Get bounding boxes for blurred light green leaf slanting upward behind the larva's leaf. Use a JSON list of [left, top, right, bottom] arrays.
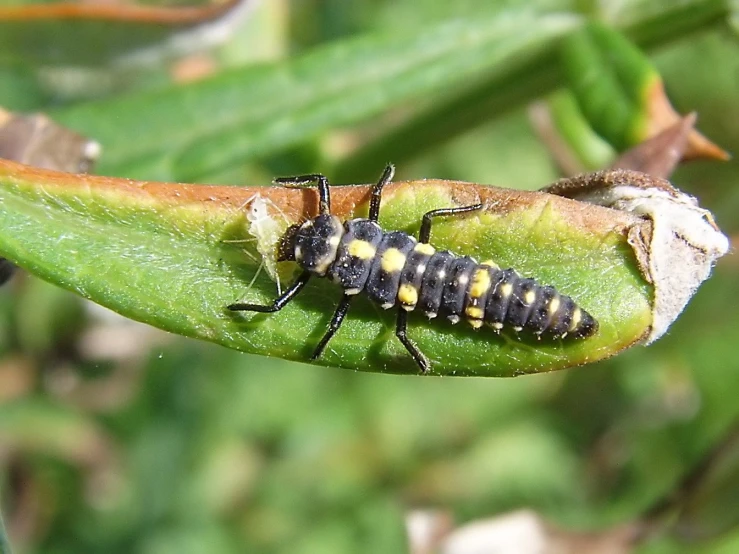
[[53, 10, 579, 181]]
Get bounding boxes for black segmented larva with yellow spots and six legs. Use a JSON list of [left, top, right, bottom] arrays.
[[228, 165, 598, 373]]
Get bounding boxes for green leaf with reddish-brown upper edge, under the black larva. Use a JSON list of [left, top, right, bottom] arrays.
[[0, 162, 651, 376]]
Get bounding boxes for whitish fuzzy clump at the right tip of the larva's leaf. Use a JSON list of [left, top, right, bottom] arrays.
[[577, 184, 729, 344]]
